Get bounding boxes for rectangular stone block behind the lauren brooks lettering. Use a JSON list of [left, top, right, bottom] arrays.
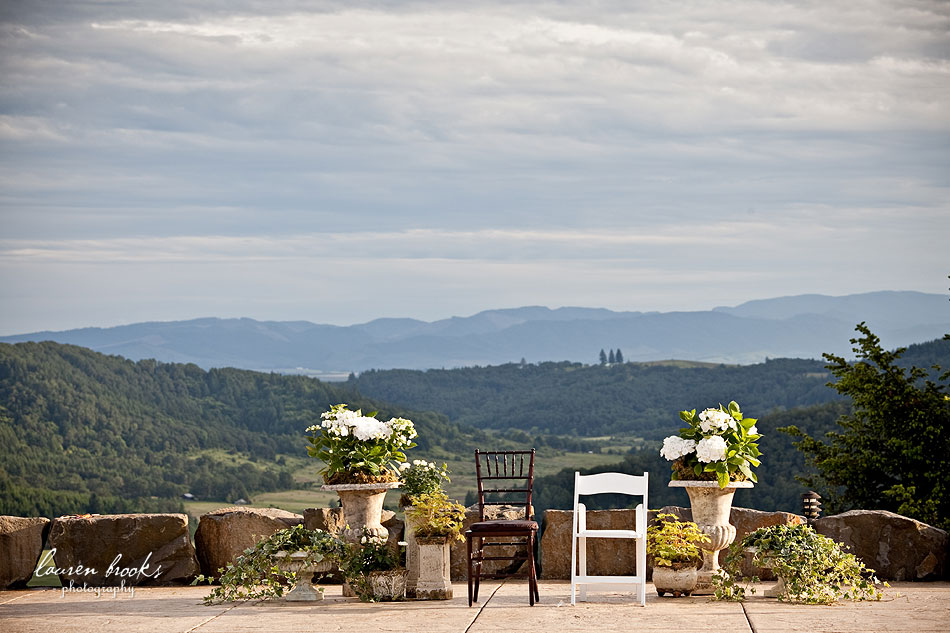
[[49, 514, 198, 587]]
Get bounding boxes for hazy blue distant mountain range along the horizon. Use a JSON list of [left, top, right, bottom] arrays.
[[0, 291, 950, 378]]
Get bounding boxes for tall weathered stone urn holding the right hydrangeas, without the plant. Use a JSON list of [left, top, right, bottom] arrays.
[[670, 480, 753, 596]]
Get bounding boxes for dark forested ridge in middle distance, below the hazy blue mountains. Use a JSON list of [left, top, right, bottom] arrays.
[[345, 352, 852, 439]]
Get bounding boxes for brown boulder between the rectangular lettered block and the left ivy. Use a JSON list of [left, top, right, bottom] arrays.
[[195, 506, 303, 578]]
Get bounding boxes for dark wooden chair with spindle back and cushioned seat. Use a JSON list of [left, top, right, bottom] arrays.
[[465, 449, 540, 606]]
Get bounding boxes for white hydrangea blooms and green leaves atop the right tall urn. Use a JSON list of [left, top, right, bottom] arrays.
[[660, 400, 761, 488]]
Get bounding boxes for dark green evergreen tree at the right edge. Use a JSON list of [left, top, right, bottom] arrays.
[[782, 323, 950, 529]]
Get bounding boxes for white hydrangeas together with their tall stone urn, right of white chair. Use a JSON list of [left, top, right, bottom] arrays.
[[660, 401, 761, 595]]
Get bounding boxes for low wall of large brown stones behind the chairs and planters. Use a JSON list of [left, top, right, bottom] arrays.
[[0, 506, 950, 589]]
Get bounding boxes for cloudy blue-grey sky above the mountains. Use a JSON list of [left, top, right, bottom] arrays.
[[0, 0, 950, 334]]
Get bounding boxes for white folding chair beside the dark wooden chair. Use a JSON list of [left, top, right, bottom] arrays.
[[571, 472, 649, 606]]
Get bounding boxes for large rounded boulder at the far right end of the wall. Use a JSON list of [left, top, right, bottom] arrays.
[[814, 510, 948, 580]]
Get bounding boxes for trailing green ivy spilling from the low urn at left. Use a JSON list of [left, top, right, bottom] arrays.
[[192, 525, 346, 604]]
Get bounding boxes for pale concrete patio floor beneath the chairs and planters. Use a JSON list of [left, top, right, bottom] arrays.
[[0, 580, 950, 633]]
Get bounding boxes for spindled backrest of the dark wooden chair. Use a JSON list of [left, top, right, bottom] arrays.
[[475, 448, 534, 521]]
